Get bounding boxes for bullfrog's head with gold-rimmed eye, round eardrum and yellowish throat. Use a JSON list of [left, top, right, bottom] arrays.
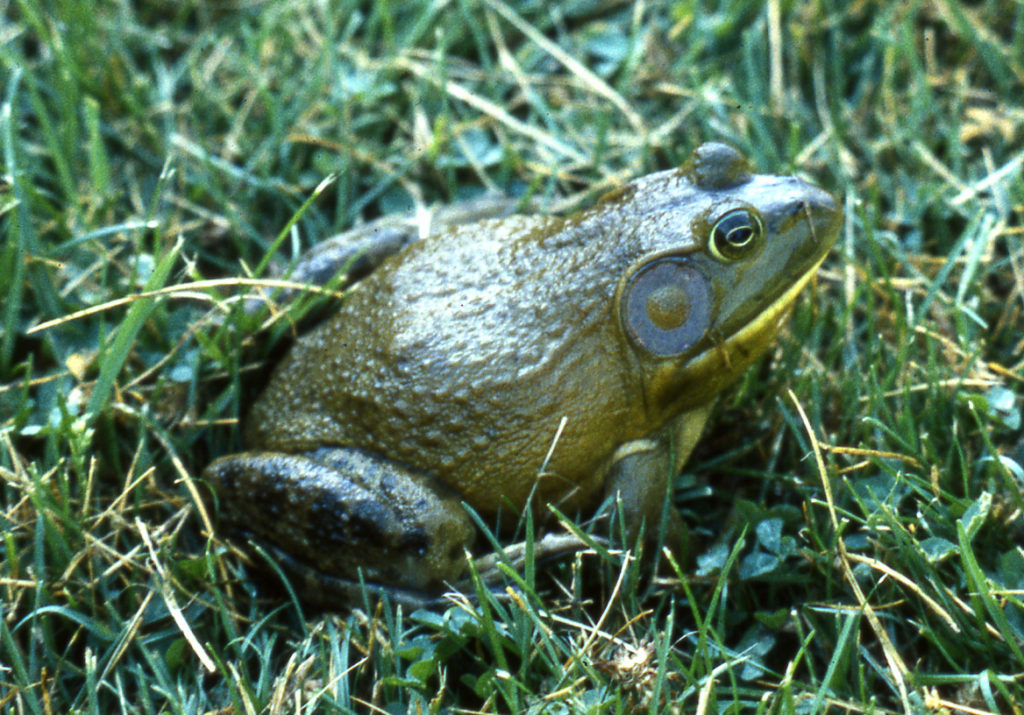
[[615, 143, 842, 411]]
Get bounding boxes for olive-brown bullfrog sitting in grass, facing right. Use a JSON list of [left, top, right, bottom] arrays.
[[204, 143, 841, 593]]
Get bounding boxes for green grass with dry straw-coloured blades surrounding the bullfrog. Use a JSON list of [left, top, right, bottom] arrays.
[[0, 0, 1024, 713]]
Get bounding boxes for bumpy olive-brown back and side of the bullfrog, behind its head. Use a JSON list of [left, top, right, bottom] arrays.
[[248, 208, 636, 510]]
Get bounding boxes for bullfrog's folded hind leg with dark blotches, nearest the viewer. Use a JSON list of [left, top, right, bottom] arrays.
[[204, 448, 474, 600]]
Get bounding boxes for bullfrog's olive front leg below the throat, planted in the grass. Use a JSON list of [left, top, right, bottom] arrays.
[[604, 405, 711, 550]]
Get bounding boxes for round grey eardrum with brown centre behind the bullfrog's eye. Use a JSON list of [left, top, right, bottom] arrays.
[[623, 256, 712, 358]]
